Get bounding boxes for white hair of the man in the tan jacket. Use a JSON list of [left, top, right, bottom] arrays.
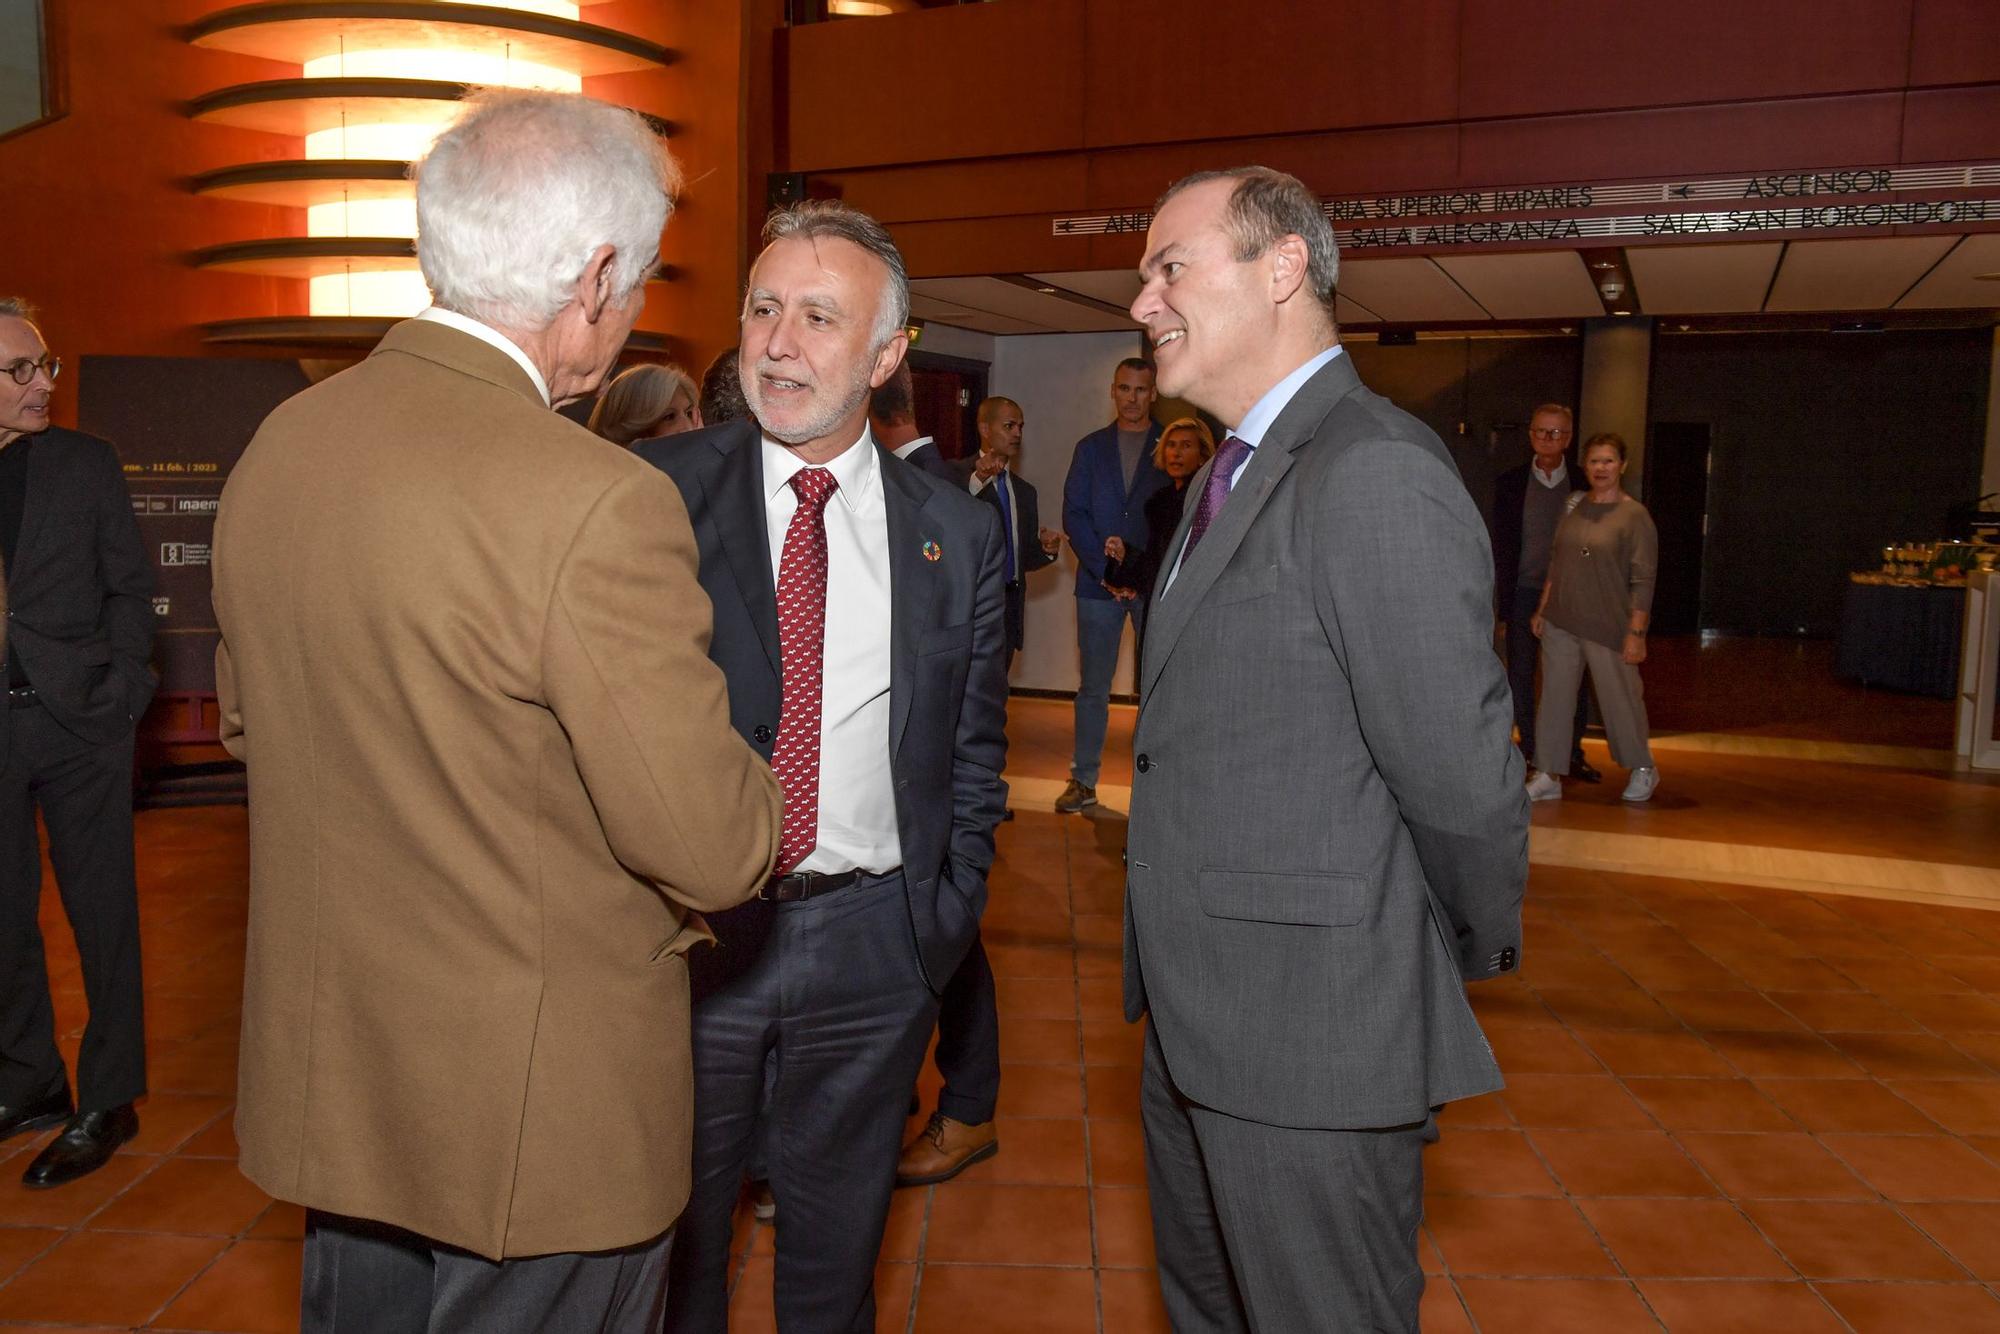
[[414, 90, 680, 330]]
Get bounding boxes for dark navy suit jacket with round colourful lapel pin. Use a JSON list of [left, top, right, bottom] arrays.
[[634, 422, 1006, 992]]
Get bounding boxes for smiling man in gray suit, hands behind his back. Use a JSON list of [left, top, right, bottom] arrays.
[[1124, 168, 1528, 1332]]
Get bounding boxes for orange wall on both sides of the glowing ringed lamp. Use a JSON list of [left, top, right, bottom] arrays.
[[0, 0, 782, 422]]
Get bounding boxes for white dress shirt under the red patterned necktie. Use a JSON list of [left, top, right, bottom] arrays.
[[764, 428, 902, 874]]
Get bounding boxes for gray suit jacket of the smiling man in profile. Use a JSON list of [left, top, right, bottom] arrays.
[[1124, 354, 1528, 1128]]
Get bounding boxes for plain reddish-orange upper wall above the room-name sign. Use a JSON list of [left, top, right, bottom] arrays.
[[780, 0, 2000, 274]]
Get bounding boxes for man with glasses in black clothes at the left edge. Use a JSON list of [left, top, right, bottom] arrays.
[[0, 300, 156, 1186]]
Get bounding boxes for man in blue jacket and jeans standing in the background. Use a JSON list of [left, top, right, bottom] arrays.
[[1056, 356, 1172, 814]]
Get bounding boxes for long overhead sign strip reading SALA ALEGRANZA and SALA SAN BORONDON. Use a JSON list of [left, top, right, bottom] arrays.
[[1052, 162, 2000, 250]]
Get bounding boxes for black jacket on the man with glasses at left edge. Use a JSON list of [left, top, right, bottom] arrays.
[[0, 426, 158, 756]]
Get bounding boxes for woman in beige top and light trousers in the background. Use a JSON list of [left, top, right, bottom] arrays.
[[1528, 432, 1660, 802]]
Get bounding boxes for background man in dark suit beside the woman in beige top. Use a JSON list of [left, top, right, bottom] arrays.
[[1488, 402, 1604, 782]]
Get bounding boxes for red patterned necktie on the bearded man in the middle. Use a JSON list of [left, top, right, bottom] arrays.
[[770, 468, 838, 876]]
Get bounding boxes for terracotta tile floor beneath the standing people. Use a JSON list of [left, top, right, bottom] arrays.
[[11, 702, 2000, 1334]]
